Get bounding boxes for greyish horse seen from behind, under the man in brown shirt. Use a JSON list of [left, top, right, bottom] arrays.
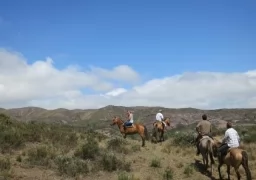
[[199, 136, 215, 175]]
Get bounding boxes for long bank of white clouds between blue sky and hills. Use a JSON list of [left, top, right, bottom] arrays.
[[0, 49, 256, 109]]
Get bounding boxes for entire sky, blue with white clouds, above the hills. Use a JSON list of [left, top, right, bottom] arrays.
[[0, 0, 256, 109]]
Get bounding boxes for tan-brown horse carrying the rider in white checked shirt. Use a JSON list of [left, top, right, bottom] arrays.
[[214, 140, 252, 180]]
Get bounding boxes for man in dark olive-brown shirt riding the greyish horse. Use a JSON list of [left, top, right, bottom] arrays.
[[196, 114, 213, 156]]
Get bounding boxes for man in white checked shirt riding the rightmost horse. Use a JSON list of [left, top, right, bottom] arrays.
[[218, 122, 240, 160]]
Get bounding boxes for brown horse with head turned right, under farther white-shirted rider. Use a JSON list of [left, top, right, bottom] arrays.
[[153, 117, 170, 142]]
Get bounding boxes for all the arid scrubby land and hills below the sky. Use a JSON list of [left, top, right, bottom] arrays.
[[0, 106, 256, 180]]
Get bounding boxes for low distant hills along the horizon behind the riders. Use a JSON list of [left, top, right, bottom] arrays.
[[0, 105, 256, 127]]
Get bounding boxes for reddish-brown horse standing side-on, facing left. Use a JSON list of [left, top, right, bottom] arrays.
[[111, 116, 148, 147]]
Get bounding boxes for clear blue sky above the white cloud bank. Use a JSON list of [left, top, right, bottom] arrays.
[[0, 0, 256, 78]]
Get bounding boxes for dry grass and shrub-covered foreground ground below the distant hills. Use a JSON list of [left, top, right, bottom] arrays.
[[0, 113, 256, 180]]
